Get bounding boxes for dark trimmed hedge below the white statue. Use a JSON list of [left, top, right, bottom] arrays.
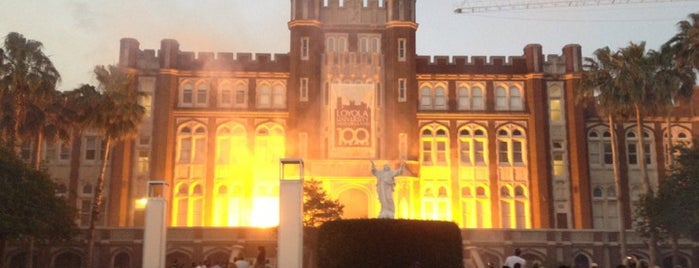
[[317, 219, 464, 268]]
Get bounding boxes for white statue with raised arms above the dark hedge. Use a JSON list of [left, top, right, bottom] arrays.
[[371, 161, 405, 219]]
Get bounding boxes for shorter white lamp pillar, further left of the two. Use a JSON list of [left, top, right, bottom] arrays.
[[143, 181, 168, 268]]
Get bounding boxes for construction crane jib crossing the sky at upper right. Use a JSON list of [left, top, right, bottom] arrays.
[[454, 0, 696, 14]]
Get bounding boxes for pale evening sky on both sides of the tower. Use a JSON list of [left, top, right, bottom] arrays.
[[0, 0, 699, 90]]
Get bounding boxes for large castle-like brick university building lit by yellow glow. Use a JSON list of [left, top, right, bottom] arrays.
[[6, 0, 699, 267]]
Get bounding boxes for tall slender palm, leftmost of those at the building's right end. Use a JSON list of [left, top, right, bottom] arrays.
[[577, 47, 633, 257]]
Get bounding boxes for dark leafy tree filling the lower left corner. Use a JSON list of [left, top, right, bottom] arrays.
[[0, 147, 77, 267]]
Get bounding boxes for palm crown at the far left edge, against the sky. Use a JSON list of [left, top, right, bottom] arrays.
[[0, 32, 61, 147]]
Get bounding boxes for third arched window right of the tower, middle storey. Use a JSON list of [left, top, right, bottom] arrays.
[[498, 127, 526, 166]]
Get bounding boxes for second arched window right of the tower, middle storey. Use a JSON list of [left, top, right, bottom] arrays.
[[459, 127, 487, 166]]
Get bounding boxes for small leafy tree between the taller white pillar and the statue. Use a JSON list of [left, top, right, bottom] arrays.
[[303, 180, 344, 227]]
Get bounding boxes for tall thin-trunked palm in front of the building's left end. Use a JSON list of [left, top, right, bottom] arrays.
[[84, 66, 145, 267]]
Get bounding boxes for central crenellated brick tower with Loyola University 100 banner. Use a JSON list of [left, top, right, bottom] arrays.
[[288, 0, 417, 163]]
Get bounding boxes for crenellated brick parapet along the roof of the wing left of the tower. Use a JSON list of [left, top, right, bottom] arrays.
[[119, 38, 289, 72]]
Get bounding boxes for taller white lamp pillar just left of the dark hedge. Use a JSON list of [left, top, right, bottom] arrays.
[[277, 158, 303, 268]]
